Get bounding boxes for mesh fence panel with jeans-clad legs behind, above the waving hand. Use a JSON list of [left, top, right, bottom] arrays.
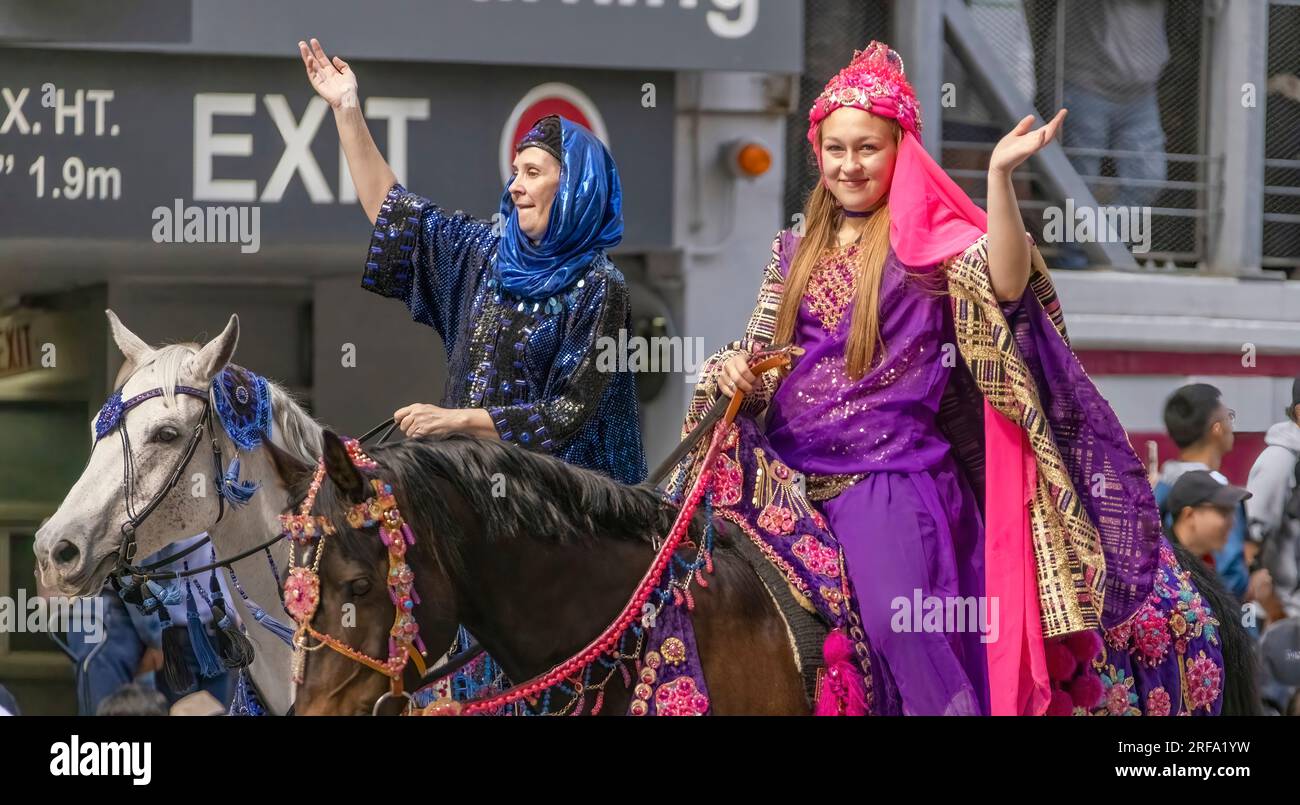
[[977, 0, 1217, 269]]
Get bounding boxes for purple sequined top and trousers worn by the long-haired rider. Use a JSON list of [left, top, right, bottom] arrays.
[[767, 246, 996, 715]]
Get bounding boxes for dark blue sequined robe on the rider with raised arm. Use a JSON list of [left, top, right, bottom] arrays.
[[361, 185, 646, 484]]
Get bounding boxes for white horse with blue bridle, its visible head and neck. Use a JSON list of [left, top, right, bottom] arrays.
[[35, 311, 321, 714]]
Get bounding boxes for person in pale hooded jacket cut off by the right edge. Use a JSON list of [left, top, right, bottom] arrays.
[[1245, 377, 1300, 618]]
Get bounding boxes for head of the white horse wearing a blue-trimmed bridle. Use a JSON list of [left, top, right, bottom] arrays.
[[35, 311, 239, 596]]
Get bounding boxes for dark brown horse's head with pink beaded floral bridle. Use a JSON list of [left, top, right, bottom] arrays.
[[285, 430, 458, 715]]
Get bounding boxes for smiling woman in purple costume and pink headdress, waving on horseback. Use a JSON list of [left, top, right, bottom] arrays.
[[686, 43, 1237, 715]]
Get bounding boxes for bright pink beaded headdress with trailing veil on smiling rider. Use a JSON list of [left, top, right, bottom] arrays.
[[809, 40, 988, 268]]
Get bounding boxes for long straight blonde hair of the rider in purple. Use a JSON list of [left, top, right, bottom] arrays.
[[775, 121, 902, 380]]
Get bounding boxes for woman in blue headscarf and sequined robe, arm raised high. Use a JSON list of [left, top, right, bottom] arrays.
[[305, 39, 646, 694]]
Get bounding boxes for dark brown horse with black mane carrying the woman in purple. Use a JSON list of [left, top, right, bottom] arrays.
[[277, 430, 810, 715]]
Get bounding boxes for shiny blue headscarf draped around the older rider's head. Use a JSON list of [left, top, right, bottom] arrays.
[[497, 117, 623, 299]]
